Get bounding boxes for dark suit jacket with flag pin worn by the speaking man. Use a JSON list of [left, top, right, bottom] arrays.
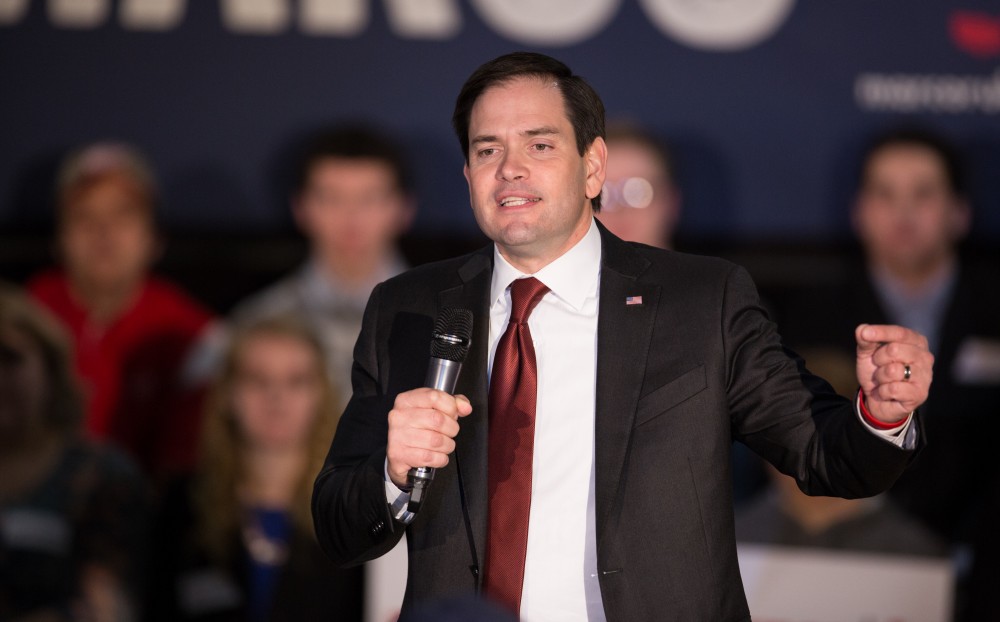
[[313, 227, 913, 622]]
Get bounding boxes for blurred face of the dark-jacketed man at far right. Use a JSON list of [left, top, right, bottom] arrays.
[[854, 144, 969, 275]]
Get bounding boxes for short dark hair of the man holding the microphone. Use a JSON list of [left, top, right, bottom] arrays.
[[451, 52, 604, 212]]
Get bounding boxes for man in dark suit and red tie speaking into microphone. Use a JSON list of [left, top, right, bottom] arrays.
[[313, 53, 932, 621]]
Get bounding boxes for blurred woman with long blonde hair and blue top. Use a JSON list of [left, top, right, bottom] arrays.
[[149, 317, 363, 621]]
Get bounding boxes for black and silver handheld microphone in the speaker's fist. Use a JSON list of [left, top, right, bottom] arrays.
[[407, 307, 472, 520]]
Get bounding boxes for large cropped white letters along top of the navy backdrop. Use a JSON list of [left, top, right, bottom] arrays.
[[0, 0, 795, 51]]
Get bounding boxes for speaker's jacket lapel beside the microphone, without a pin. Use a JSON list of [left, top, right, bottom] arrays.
[[439, 246, 493, 572]]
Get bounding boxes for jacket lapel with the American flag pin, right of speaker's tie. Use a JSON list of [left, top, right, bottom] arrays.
[[594, 223, 660, 549]]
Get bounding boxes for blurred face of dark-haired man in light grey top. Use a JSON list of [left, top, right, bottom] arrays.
[[294, 157, 413, 271]]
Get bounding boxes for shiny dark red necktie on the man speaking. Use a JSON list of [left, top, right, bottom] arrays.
[[484, 278, 549, 612]]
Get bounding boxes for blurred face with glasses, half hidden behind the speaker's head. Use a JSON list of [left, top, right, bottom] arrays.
[[597, 139, 680, 248]]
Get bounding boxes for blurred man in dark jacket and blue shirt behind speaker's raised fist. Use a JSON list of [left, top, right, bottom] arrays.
[[782, 127, 1000, 620]]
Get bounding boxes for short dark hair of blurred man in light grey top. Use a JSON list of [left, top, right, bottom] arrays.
[[294, 124, 412, 193]]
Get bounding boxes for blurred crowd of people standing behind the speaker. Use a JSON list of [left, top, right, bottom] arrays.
[[0, 122, 1000, 621]]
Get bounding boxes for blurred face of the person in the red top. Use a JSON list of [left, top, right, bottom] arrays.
[[59, 174, 157, 290]]
